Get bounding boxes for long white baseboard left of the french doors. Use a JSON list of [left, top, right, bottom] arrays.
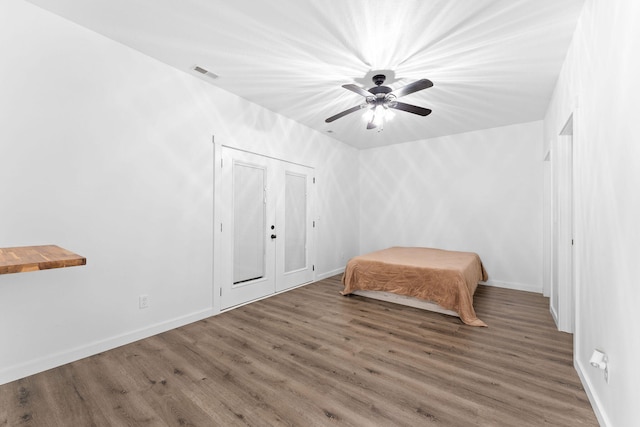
[[0, 309, 214, 385]]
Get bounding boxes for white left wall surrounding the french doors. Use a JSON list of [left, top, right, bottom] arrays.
[[0, 0, 358, 383]]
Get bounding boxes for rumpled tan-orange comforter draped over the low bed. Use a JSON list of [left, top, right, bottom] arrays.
[[342, 247, 488, 326]]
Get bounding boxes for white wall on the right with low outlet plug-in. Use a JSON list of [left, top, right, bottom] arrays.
[[544, 0, 640, 426]]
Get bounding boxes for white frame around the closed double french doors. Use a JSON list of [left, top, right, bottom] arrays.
[[212, 144, 317, 314]]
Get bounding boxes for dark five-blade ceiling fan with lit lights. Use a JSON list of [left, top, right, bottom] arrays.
[[325, 74, 433, 129]]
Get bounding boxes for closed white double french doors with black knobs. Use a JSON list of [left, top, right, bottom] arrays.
[[216, 147, 313, 309]]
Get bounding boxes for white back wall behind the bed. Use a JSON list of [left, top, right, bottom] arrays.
[[360, 122, 543, 292]]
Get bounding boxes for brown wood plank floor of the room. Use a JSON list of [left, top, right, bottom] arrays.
[[0, 277, 597, 427]]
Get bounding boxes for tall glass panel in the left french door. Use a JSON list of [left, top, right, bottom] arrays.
[[233, 163, 266, 285]]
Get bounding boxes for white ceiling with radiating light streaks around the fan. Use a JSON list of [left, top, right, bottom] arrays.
[[30, 0, 584, 148]]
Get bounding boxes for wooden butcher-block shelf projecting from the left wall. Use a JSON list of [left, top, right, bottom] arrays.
[[0, 245, 87, 274]]
